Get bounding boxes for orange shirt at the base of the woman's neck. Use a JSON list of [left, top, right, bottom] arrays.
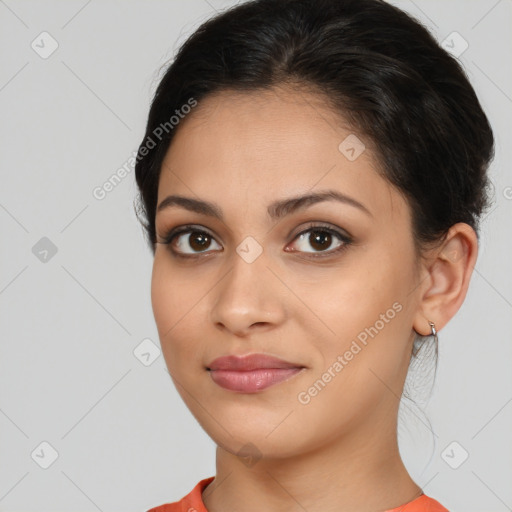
[[147, 476, 448, 512]]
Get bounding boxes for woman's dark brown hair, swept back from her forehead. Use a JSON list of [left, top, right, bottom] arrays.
[[135, 0, 494, 260]]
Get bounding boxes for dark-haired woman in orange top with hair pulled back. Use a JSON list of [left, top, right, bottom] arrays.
[[136, 0, 494, 512]]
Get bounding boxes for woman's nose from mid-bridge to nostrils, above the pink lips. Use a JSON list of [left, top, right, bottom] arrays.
[[211, 254, 286, 337]]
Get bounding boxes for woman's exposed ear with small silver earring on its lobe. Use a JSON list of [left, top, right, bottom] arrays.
[[413, 222, 478, 336]]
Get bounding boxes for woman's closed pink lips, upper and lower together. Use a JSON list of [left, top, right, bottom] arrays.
[[207, 354, 305, 393]]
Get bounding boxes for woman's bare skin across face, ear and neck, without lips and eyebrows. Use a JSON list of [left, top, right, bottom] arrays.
[[151, 86, 478, 512]]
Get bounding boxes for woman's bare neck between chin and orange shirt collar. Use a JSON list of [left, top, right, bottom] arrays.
[[203, 414, 422, 512]]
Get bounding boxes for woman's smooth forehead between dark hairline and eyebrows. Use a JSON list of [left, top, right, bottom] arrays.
[[158, 87, 405, 224]]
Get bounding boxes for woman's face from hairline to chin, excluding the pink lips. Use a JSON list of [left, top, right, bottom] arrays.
[[151, 88, 419, 458]]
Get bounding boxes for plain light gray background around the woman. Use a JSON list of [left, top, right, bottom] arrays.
[[0, 0, 512, 512]]
